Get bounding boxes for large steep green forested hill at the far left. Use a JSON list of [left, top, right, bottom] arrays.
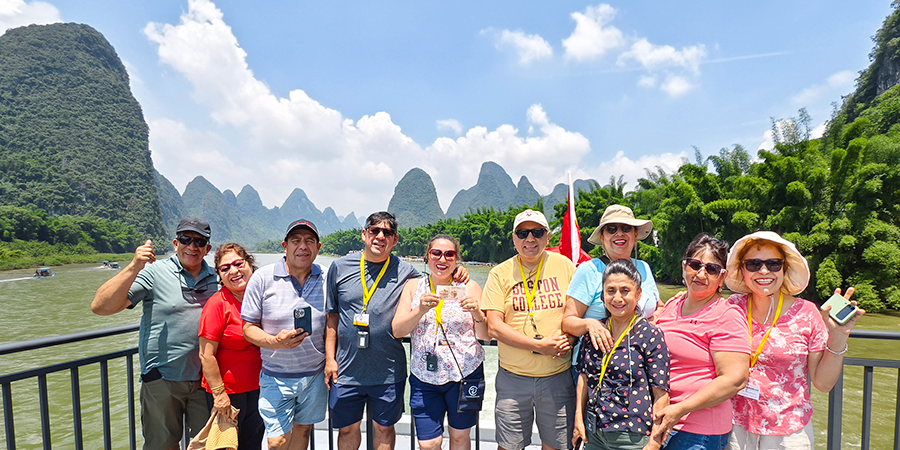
[[0, 24, 165, 237]]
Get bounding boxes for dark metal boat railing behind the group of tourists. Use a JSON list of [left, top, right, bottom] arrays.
[[0, 324, 900, 450]]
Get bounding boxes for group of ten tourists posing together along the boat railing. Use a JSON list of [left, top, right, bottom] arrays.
[[91, 205, 864, 450]]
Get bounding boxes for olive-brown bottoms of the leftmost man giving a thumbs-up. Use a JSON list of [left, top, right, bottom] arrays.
[[141, 378, 209, 450]]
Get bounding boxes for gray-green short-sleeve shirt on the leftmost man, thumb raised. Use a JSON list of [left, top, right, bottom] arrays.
[[128, 255, 219, 381]]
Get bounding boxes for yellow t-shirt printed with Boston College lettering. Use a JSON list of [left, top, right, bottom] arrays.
[[481, 252, 575, 377]]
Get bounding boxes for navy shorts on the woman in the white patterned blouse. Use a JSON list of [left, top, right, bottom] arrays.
[[409, 364, 484, 441]]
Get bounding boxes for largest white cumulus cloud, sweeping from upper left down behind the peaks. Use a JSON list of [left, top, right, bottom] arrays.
[[144, 0, 604, 216]]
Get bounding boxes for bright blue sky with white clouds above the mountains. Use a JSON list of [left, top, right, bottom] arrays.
[[0, 0, 891, 220]]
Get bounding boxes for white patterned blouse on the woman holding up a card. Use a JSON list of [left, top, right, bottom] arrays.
[[409, 278, 484, 385]]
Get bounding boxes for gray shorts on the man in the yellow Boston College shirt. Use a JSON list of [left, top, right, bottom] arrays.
[[494, 367, 575, 450]]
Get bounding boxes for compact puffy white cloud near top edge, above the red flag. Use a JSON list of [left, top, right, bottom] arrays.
[[563, 4, 625, 61]]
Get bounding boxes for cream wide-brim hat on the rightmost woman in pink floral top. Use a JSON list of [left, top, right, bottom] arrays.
[[725, 231, 809, 295]]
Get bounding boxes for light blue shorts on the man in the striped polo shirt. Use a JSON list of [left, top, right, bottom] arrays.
[[259, 372, 328, 438]]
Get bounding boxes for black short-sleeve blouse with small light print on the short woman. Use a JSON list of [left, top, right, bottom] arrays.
[[577, 318, 669, 436]]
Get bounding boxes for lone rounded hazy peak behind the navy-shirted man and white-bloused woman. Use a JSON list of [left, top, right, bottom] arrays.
[[388, 167, 444, 228]]
